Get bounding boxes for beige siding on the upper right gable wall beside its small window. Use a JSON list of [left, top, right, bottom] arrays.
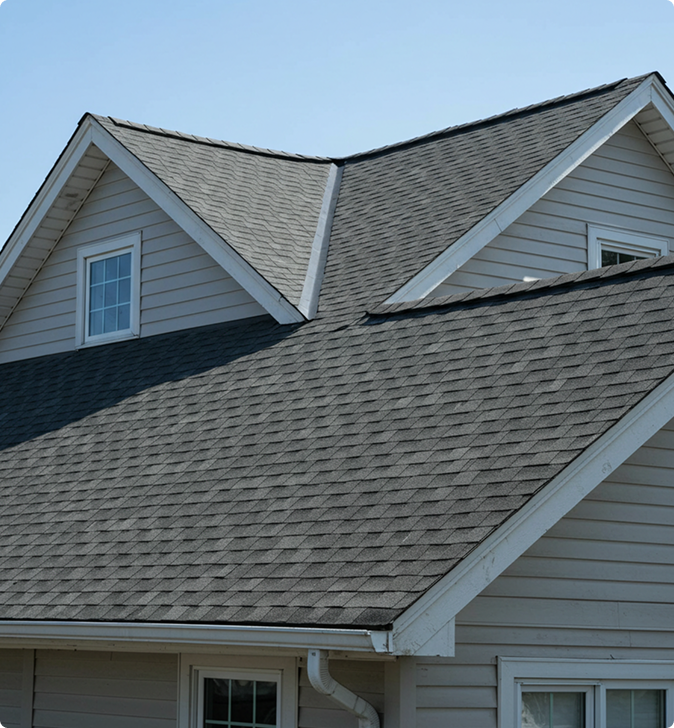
[[431, 122, 674, 296]]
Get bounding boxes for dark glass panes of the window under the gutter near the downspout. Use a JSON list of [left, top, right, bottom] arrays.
[[203, 677, 279, 728]]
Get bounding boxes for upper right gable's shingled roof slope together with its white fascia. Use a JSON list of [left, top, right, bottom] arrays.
[[321, 74, 672, 310]]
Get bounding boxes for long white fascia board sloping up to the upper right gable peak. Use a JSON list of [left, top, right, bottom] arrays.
[[385, 76, 657, 304]]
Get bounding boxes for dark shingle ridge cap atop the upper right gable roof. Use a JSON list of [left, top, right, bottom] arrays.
[[336, 71, 662, 161]]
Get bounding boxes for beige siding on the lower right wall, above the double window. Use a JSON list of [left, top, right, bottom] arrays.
[[417, 421, 674, 728]]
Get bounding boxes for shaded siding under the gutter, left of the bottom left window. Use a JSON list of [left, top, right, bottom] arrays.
[[33, 650, 178, 728]]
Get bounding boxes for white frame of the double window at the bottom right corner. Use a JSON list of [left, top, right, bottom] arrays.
[[498, 657, 674, 728]]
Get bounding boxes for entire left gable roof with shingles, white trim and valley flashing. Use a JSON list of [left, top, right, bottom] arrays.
[[0, 114, 340, 328]]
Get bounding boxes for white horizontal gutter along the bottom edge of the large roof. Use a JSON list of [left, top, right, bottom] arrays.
[[0, 620, 391, 654]]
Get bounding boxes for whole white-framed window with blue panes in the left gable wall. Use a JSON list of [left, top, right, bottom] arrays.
[[77, 233, 140, 346]]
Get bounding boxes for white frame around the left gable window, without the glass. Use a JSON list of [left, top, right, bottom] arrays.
[[75, 232, 141, 348]]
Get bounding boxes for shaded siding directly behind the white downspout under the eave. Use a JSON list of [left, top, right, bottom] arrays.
[[298, 660, 384, 728]]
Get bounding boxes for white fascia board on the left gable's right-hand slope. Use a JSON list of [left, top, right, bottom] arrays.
[[91, 119, 305, 324]]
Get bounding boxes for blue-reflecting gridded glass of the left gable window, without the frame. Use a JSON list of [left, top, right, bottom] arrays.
[[87, 251, 132, 337]]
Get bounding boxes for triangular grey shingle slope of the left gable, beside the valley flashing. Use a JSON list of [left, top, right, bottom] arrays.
[[94, 116, 329, 305]]
